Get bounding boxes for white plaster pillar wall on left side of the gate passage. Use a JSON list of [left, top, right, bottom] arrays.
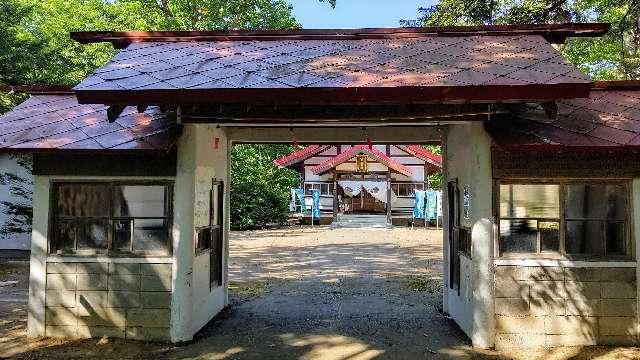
[[171, 124, 230, 342]]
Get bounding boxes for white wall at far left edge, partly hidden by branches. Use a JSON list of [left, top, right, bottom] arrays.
[[0, 154, 33, 250]]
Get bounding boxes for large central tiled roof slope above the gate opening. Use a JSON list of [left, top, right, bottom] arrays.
[[72, 35, 588, 91]]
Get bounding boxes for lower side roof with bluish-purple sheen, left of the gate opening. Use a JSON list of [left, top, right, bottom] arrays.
[[0, 93, 180, 152]]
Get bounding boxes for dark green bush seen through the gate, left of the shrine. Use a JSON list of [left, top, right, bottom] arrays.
[[231, 145, 299, 229]]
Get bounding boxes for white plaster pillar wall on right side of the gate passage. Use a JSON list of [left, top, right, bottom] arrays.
[[443, 123, 495, 348]]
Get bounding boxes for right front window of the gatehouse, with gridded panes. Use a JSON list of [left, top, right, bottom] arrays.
[[498, 181, 630, 258]]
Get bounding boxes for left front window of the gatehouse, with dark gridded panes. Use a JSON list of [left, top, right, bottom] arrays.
[[49, 181, 173, 256]]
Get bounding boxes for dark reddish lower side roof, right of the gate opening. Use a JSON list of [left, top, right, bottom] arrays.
[[487, 81, 640, 149]]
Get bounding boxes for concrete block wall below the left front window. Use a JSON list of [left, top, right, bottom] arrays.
[[45, 262, 172, 341]]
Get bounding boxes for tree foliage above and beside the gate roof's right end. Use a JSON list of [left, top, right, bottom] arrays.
[[401, 0, 640, 79]]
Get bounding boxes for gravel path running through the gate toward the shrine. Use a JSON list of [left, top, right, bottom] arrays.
[[176, 227, 481, 359]]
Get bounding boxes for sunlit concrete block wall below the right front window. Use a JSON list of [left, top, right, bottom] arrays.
[[495, 266, 638, 349]]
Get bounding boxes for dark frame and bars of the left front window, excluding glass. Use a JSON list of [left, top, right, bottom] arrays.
[[47, 179, 174, 257]]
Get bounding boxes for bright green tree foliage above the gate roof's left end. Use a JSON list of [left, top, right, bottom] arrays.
[[0, 0, 300, 85]]
